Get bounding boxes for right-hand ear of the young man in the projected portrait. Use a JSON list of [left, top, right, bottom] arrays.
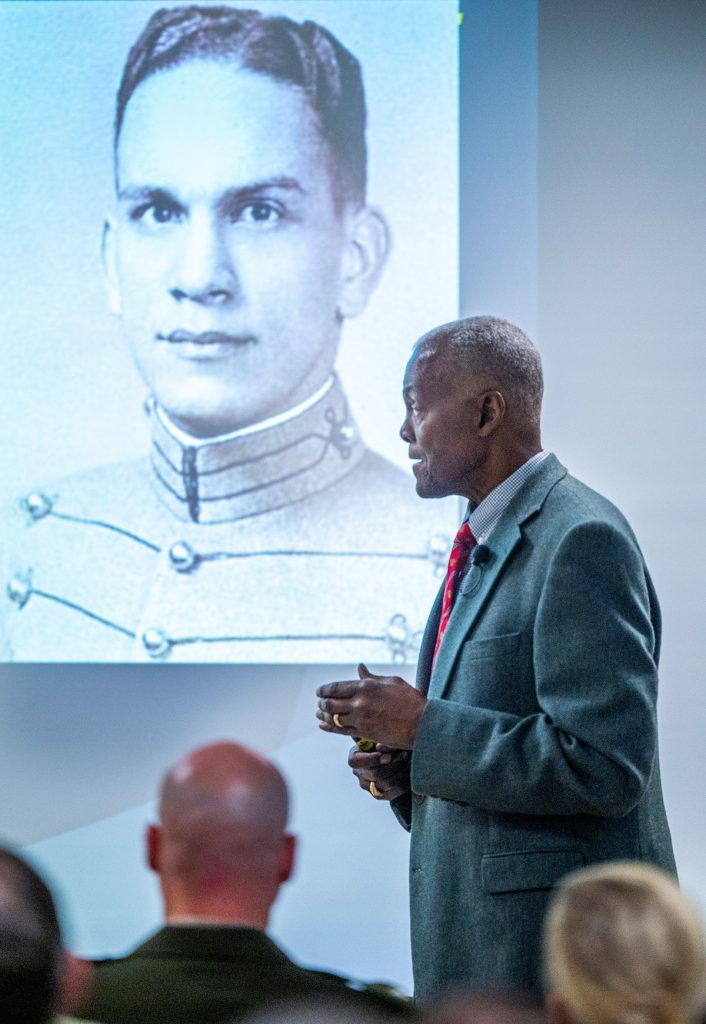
[[337, 206, 390, 319]]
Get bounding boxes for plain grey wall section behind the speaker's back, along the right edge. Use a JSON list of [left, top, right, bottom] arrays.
[[539, 0, 706, 906]]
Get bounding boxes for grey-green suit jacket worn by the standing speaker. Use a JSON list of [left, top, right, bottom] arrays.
[[394, 456, 674, 998]]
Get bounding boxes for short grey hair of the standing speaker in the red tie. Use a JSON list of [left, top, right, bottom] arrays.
[[419, 316, 544, 426]]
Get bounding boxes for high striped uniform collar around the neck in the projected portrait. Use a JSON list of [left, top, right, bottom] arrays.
[[149, 376, 365, 523]]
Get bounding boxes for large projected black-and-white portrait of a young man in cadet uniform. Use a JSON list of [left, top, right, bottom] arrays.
[[0, 0, 458, 664]]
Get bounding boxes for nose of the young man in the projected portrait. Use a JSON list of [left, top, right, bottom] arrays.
[[169, 212, 238, 305]]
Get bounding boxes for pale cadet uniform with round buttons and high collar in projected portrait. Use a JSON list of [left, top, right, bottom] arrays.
[[0, 378, 455, 664]]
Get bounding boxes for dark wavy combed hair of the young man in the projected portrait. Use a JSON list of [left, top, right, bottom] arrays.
[[114, 6, 367, 203]]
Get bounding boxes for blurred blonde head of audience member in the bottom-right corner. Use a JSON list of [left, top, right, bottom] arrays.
[[544, 862, 706, 1024]]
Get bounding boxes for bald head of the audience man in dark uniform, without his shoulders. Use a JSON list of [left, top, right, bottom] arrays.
[[148, 742, 295, 930]]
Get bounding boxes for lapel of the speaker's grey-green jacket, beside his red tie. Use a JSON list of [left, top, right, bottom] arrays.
[[424, 455, 567, 697]]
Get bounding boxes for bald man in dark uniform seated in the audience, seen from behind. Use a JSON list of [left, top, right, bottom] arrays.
[[80, 742, 407, 1024]]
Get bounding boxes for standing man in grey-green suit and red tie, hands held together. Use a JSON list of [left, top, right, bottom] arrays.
[[318, 317, 674, 998]]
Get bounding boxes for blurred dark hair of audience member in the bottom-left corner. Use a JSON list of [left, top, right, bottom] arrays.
[[0, 848, 63, 1024]]
